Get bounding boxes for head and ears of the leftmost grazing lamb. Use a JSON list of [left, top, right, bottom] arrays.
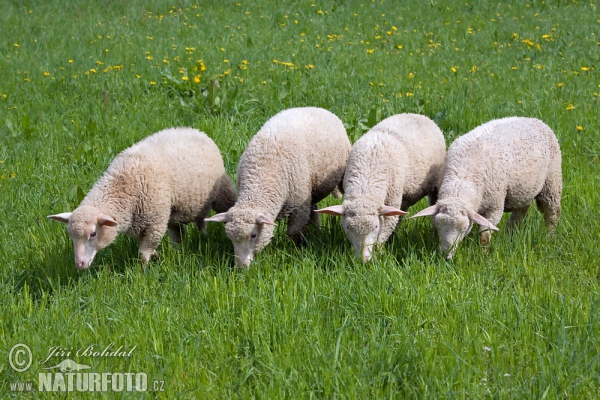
[[49, 206, 118, 269]]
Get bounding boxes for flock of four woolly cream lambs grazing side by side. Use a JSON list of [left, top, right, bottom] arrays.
[[48, 107, 562, 269]]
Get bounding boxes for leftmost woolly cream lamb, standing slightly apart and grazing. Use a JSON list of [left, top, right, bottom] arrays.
[[48, 128, 236, 269]]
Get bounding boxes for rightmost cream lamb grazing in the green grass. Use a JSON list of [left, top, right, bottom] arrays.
[[411, 117, 562, 259]]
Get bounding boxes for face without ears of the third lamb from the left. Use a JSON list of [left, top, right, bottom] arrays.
[[342, 214, 383, 263]]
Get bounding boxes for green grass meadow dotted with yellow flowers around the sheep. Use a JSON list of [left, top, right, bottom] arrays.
[[0, 0, 600, 399]]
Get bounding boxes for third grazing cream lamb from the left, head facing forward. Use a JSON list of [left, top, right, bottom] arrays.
[[316, 114, 446, 263]]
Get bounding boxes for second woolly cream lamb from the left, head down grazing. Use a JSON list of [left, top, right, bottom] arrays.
[[206, 107, 351, 268]]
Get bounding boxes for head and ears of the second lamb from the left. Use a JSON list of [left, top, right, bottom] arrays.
[[205, 208, 275, 269]]
